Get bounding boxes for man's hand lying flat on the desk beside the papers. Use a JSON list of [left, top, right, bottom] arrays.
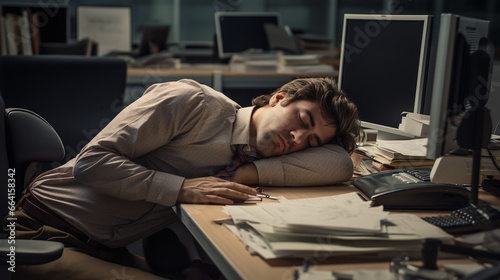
[[177, 177, 257, 204]]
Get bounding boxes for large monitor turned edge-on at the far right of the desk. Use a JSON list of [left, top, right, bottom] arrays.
[[427, 14, 494, 159]]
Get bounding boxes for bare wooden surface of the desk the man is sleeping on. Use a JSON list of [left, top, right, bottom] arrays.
[[178, 185, 500, 280]]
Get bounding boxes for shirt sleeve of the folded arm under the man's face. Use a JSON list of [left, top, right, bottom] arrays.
[[253, 144, 353, 186]]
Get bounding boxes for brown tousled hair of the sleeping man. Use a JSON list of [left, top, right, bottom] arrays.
[[252, 78, 361, 153]]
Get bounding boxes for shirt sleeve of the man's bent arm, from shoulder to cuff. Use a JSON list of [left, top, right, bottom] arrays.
[[73, 82, 205, 206]]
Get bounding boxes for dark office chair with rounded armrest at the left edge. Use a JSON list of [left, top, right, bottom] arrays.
[[0, 95, 64, 279]]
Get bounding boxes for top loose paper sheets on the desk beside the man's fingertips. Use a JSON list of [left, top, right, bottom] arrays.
[[225, 193, 388, 234]]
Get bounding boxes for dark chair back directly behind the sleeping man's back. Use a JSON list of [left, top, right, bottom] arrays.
[[0, 55, 127, 164]]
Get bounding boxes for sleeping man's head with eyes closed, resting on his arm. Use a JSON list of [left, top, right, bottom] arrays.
[[251, 78, 360, 157]]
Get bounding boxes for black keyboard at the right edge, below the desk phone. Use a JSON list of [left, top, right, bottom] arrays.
[[422, 204, 500, 233]]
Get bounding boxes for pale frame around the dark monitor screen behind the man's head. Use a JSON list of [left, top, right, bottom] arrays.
[[338, 14, 432, 139]]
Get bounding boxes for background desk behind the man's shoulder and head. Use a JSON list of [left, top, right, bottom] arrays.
[[124, 64, 338, 107]]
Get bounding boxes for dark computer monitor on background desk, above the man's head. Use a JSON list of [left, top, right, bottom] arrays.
[[215, 12, 281, 58]]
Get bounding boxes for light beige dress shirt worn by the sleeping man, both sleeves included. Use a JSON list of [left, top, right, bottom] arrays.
[[32, 80, 352, 247]]
